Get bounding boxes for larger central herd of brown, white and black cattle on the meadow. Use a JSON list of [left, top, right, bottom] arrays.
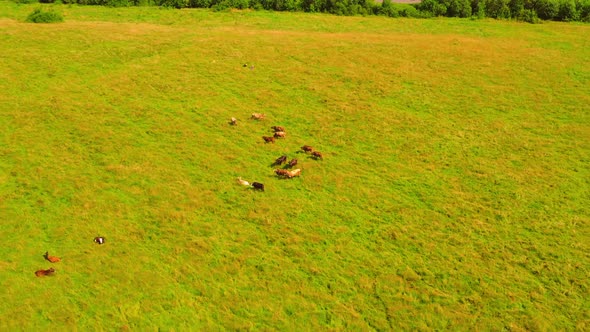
[[234, 113, 324, 191]]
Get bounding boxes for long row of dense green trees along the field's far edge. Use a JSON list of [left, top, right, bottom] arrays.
[[20, 0, 590, 23]]
